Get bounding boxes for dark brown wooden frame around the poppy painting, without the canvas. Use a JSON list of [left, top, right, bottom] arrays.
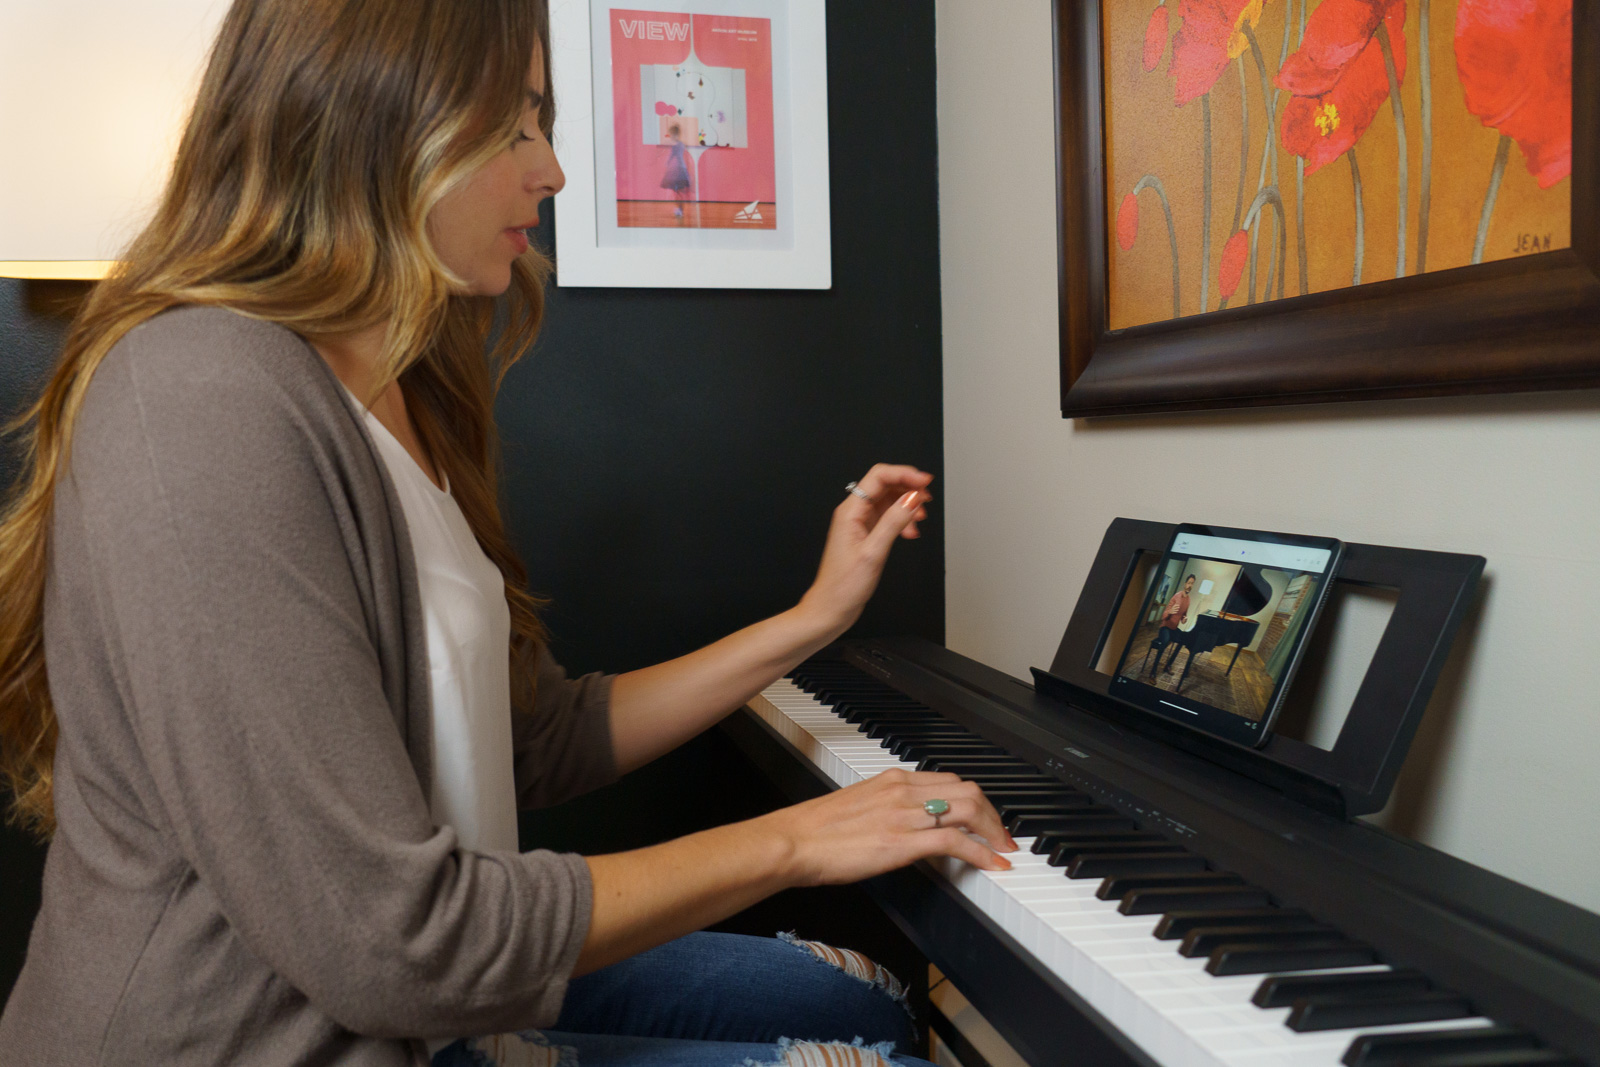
[[1054, 0, 1600, 418]]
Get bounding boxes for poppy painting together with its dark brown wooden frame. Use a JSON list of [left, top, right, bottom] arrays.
[[1056, 0, 1600, 418]]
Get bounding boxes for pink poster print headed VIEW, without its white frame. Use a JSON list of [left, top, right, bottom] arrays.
[[608, 8, 778, 230]]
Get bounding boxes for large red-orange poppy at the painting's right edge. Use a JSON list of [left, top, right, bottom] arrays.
[[1456, 0, 1573, 189]]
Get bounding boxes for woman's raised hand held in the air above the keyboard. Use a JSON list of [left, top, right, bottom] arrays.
[[800, 464, 933, 635]]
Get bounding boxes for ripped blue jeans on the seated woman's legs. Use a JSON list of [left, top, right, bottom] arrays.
[[432, 933, 930, 1067]]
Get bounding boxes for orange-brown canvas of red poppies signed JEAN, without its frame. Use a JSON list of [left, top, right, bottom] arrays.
[[1107, 0, 1574, 331]]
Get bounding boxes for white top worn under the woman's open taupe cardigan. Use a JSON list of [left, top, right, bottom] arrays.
[[350, 394, 517, 851]]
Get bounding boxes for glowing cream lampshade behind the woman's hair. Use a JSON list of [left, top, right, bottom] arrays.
[[0, 0, 227, 278]]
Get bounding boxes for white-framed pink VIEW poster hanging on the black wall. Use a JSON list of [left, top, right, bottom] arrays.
[[550, 0, 832, 290]]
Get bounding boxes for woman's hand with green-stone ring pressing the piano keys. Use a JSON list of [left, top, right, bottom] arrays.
[[762, 769, 1016, 885]]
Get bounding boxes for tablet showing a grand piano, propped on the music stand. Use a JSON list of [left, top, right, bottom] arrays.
[[1110, 523, 1344, 747]]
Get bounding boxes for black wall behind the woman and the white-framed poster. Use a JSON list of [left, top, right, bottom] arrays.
[[0, 3, 944, 998]]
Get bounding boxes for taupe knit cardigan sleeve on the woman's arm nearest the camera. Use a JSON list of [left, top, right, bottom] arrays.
[[54, 320, 592, 1038]]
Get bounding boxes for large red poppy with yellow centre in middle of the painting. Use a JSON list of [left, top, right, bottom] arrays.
[[1277, 0, 1405, 174]]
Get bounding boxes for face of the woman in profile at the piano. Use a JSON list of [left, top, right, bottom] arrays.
[[427, 48, 566, 296]]
